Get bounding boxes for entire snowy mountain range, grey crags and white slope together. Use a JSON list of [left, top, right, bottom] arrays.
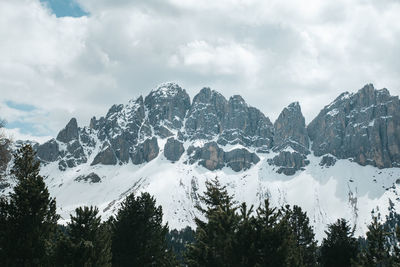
[[3, 83, 400, 239]]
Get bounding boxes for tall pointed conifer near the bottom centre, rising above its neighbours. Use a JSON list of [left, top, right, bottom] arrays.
[[187, 178, 239, 267]]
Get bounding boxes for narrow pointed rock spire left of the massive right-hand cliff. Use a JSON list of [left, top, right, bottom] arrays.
[[274, 102, 309, 154]]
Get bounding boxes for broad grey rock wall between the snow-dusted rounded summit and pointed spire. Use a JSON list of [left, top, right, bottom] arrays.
[[185, 88, 273, 148]]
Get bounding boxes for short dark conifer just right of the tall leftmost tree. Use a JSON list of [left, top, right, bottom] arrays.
[[56, 207, 111, 267]]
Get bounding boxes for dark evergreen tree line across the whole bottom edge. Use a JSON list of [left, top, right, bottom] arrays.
[[0, 145, 400, 267]]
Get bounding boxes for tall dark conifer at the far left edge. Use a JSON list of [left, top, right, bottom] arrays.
[[0, 145, 59, 266]]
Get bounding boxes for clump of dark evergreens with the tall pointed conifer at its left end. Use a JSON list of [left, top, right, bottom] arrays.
[[187, 179, 310, 266]]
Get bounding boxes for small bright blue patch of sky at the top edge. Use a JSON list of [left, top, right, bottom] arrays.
[[40, 0, 89, 18]]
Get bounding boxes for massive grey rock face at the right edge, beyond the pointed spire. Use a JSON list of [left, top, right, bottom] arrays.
[[307, 84, 400, 168]]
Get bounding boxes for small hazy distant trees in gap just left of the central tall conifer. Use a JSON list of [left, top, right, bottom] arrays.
[[167, 226, 195, 265]]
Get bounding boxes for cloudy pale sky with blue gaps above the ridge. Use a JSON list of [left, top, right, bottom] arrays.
[[0, 0, 400, 143]]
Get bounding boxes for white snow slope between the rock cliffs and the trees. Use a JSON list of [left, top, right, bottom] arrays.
[[33, 139, 400, 239]]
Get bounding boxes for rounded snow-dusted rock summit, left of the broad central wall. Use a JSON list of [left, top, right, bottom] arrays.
[[144, 83, 190, 137]]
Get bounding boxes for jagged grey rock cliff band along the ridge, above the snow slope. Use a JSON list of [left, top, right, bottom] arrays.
[[36, 83, 400, 175]]
